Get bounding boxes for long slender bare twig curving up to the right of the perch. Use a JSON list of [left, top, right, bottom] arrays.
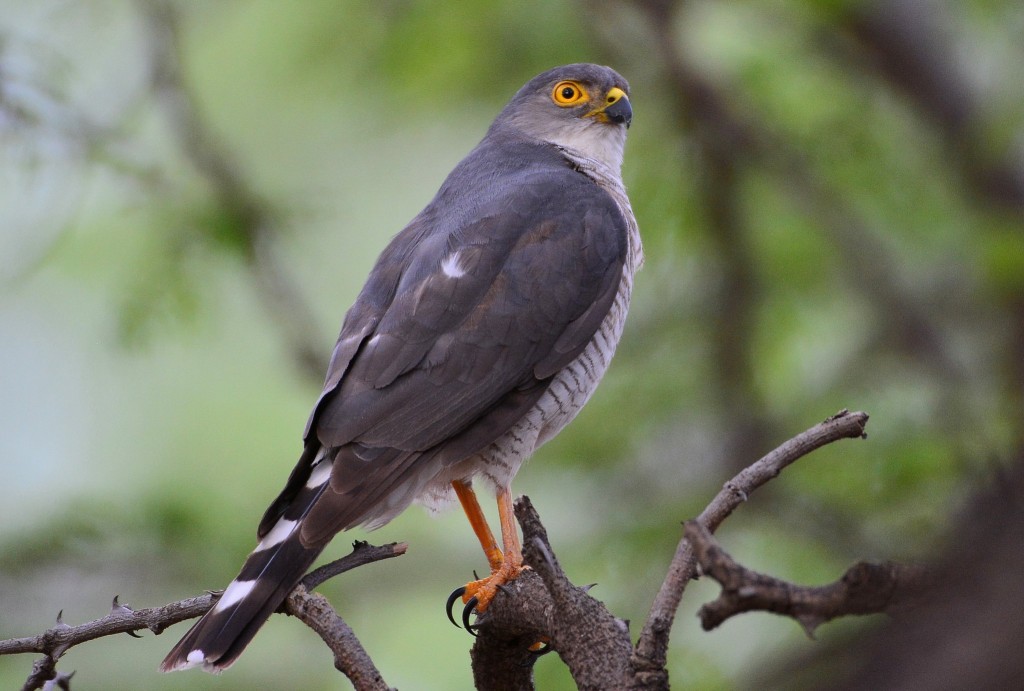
[[632, 409, 867, 689]]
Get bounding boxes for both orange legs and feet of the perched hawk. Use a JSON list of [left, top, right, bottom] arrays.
[[452, 481, 523, 613]]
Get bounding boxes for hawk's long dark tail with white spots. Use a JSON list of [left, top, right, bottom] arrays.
[[160, 450, 331, 673]]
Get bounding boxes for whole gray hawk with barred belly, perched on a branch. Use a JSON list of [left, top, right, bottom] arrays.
[[161, 63, 642, 672]]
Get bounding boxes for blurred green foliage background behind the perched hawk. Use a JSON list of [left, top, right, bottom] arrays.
[[0, 0, 1024, 689]]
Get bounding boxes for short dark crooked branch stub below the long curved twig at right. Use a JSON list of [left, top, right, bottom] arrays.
[[686, 521, 932, 638]]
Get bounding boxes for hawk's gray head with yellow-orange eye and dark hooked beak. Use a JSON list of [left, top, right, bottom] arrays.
[[493, 62, 633, 172]]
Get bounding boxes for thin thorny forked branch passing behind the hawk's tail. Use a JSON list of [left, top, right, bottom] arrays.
[[0, 543, 408, 691]]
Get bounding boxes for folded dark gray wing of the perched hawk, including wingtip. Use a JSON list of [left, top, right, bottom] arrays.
[[260, 168, 627, 544]]
